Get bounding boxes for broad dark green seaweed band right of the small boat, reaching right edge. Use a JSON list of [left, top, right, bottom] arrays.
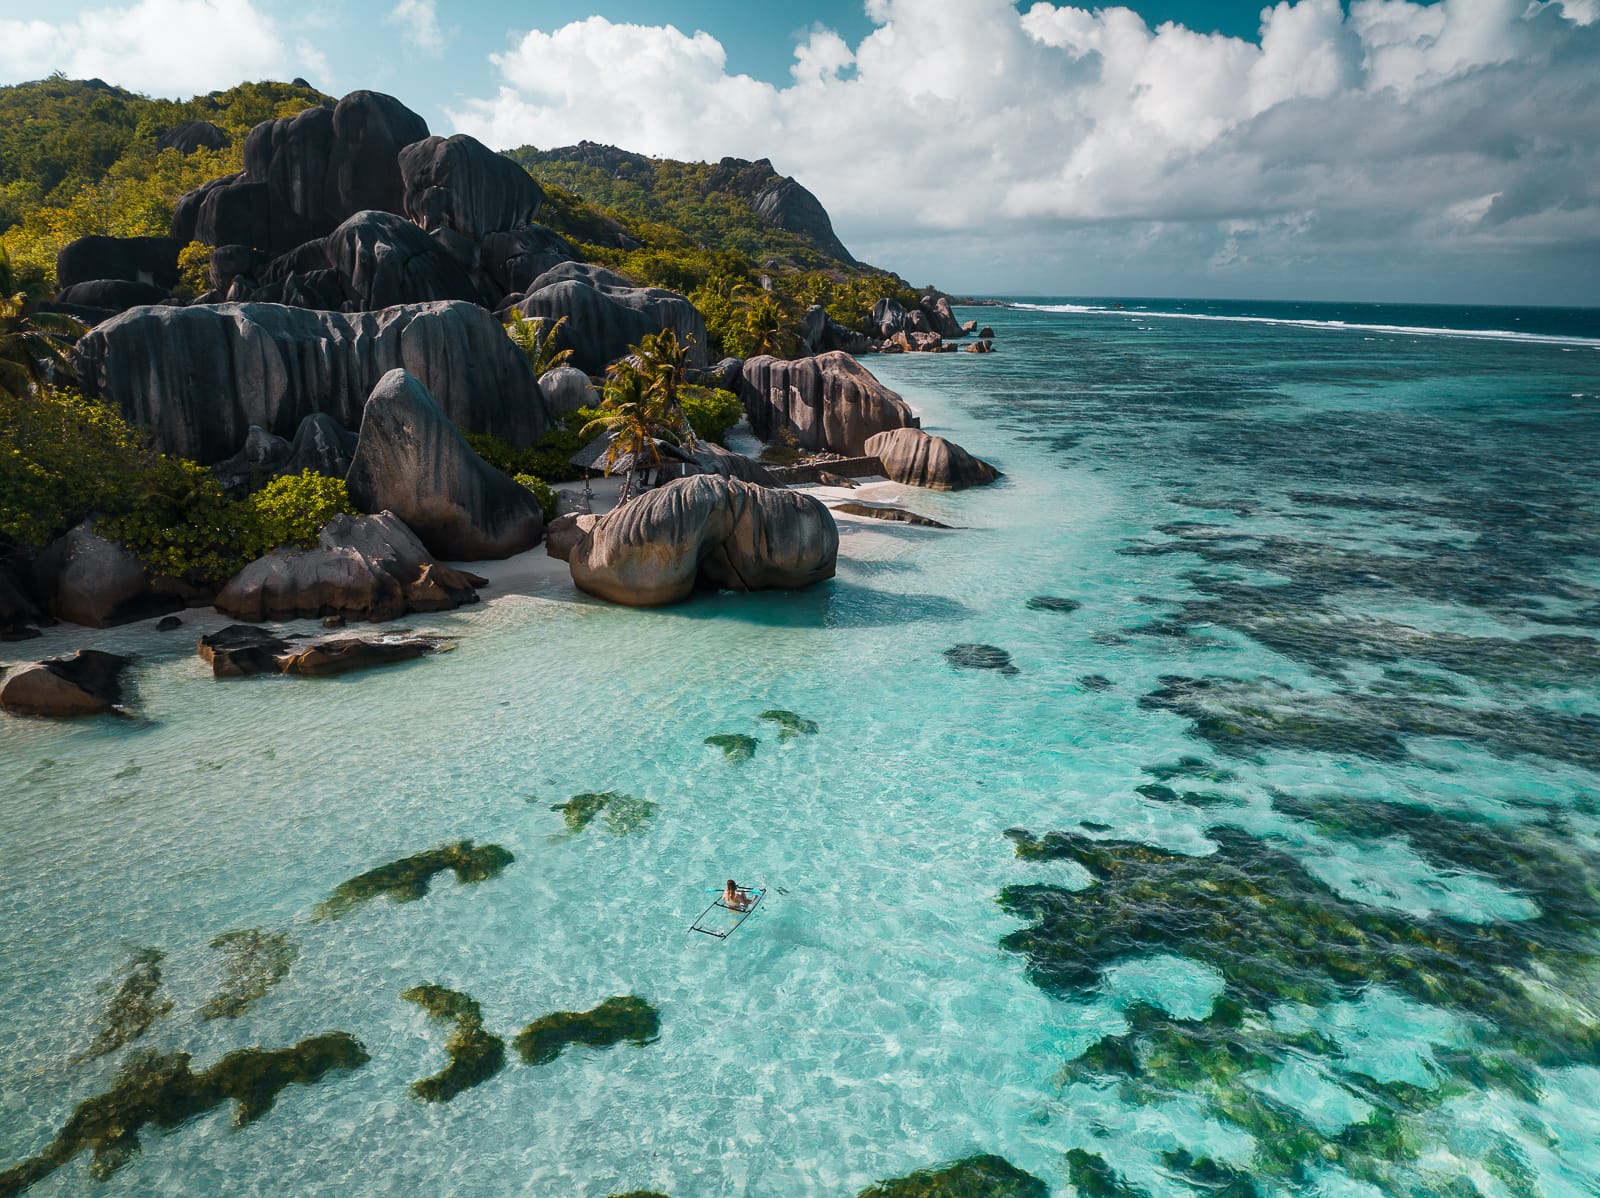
[[1000, 827, 1600, 1064]]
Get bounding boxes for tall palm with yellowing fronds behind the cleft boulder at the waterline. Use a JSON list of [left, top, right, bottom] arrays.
[[582, 329, 694, 505]]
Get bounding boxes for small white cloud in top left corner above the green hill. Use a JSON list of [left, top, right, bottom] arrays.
[[0, 0, 328, 98]]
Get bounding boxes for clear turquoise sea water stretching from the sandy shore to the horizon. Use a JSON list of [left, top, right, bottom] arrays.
[[0, 301, 1600, 1198]]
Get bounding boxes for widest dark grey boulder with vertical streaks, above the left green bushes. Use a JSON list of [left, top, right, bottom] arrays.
[[77, 302, 550, 462]]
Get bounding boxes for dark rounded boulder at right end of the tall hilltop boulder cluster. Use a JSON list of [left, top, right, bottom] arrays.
[[400, 133, 544, 242]]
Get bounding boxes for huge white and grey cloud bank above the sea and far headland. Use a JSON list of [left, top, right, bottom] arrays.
[[450, 0, 1600, 299]]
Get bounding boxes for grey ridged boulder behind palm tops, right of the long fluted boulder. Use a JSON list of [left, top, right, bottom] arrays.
[[502, 262, 706, 374]]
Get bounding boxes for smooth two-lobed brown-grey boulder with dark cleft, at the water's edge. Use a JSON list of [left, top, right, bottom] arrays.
[[568, 475, 838, 608]]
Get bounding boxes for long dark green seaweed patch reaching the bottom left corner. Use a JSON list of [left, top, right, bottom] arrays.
[[0, 1032, 371, 1198]]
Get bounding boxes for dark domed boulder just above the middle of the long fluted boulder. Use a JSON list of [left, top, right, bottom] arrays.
[[325, 211, 478, 310]]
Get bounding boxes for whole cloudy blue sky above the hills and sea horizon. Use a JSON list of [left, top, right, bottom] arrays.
[[0, 0, 1600, 304]]
